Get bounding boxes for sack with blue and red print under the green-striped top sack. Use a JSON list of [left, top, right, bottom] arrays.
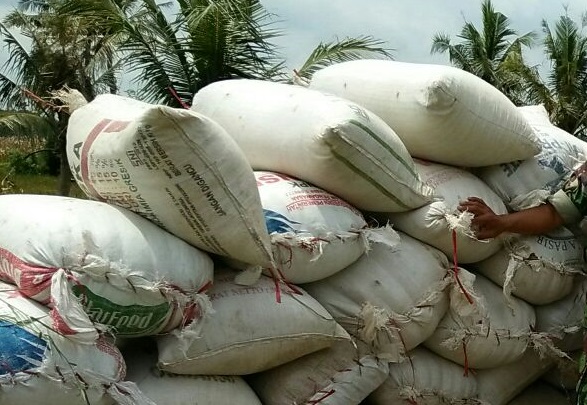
[[255, 171, 395, 284]]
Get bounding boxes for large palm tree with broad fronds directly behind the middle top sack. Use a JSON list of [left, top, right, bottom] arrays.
[[62, 0, 389, 107]]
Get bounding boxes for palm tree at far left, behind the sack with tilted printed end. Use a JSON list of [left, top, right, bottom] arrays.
[[0, 0, 124, 195]]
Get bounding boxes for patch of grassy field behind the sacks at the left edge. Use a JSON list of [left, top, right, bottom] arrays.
[[0, 137, 85, 198]]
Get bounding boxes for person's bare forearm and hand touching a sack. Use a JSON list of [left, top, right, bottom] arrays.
[[458, 197, 564, 239]]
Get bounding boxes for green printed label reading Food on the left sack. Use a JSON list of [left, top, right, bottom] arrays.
[[72, 285, 171, 337]]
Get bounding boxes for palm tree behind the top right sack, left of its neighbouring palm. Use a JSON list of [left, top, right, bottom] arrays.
[[431, 0, 535, 103]]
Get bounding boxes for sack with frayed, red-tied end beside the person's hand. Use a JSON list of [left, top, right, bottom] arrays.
[[380, 160, 507, 263]]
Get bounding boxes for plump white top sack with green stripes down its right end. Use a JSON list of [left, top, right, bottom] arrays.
[[191, 79, 430, 211]]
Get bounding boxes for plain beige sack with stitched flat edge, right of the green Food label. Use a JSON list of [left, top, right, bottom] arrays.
[[157, 269, 350, 375]]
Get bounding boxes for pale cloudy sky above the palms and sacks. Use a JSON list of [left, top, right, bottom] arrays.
[[0, 0, 587, 77]]
